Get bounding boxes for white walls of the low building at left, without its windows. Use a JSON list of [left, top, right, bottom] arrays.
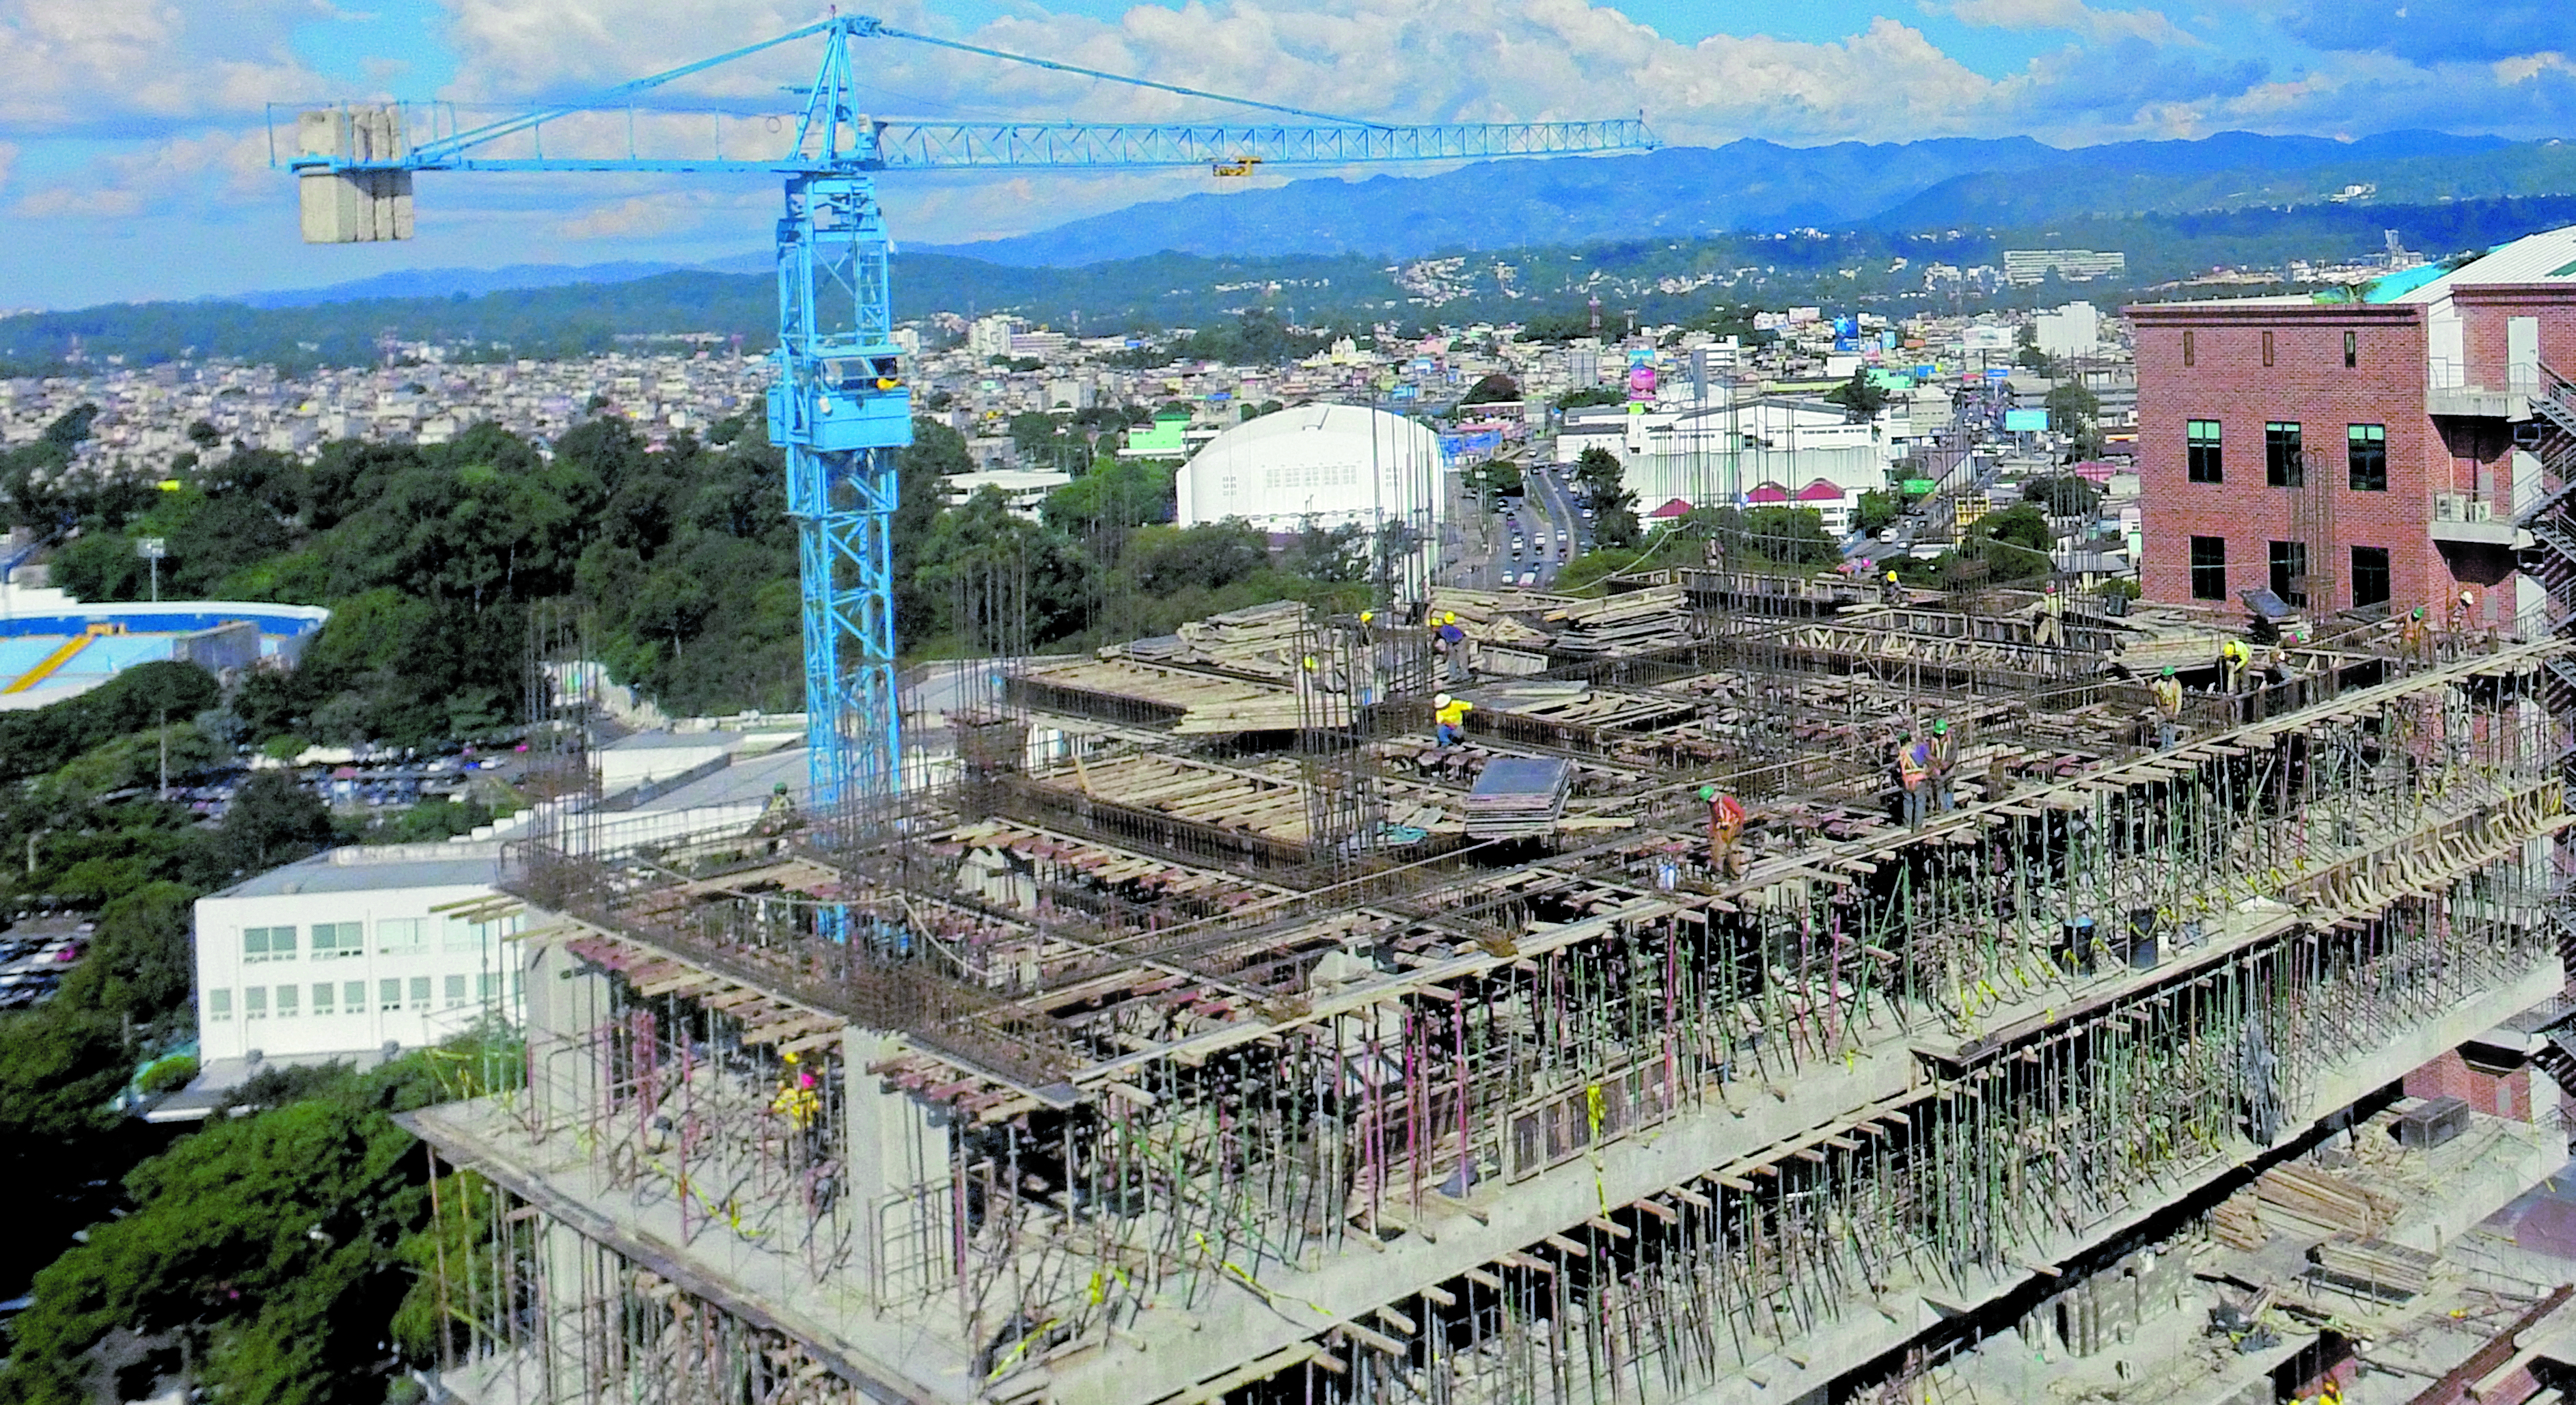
[[196, 884, 521, 1059]]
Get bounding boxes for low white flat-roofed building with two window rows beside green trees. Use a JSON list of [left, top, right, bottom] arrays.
[[196, 843, 521, 1075]]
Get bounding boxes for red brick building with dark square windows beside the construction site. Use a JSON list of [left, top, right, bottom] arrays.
[[2128, 227, 2576, 634]]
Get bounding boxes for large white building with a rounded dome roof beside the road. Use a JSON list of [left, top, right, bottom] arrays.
[[1175, 405, 1448, 549]]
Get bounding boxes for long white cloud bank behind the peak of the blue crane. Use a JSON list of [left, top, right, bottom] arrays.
[[427, 0, 1997, 139]]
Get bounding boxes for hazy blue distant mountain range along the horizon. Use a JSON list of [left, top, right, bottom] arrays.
[[190, 131, 2576, 307]]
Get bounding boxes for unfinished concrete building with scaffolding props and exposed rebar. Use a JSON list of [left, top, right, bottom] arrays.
[[409, 570, 2576, 1405]]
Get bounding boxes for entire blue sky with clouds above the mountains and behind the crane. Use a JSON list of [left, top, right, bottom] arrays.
[[0, 0, 2576, 310]]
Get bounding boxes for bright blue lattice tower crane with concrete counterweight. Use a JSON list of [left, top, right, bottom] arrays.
[[271, 16, 1656, 815]]
